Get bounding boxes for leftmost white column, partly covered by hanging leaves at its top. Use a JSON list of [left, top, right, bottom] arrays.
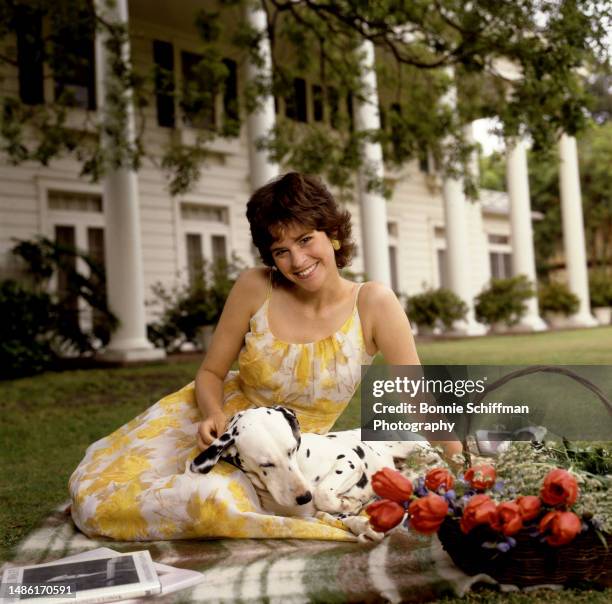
[[96, 0, 165, 361]]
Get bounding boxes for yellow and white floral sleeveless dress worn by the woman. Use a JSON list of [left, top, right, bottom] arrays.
[[69, 286, 372, 540]]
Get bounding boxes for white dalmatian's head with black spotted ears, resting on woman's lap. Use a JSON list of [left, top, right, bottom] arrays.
[[191, 406, 312, 506]]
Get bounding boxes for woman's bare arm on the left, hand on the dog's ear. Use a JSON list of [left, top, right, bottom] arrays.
[[195, 268, 268, 449]]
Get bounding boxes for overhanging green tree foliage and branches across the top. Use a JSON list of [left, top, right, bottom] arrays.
[[0, 0, 611, 193]]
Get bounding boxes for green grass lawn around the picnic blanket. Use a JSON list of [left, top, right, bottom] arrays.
[[0, 327, 612, 603]]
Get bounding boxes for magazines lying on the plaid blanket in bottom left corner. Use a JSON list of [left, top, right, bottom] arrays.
[[0, 547, 204, 604]]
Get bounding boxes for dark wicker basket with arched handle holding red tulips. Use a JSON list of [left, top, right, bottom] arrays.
[[438, 366, 612, 587]]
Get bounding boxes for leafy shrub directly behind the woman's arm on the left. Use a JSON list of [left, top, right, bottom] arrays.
[[147, 256, 245, 350]]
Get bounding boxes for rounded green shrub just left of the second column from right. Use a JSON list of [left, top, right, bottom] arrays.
[[474, 275, 534, 326]]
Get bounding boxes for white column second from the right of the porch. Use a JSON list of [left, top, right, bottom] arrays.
[[506, 139, 546, 331]]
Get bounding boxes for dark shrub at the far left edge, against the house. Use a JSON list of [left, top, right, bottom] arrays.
[[0, 279, 57, 379]]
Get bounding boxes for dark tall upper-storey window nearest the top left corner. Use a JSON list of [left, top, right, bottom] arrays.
[[15, 6, 45, 105]]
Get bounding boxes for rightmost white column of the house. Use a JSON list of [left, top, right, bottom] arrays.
[[559, 134, 597, 327]]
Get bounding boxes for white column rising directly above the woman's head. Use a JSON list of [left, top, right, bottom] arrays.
[[245, 2, 279, 191]]
